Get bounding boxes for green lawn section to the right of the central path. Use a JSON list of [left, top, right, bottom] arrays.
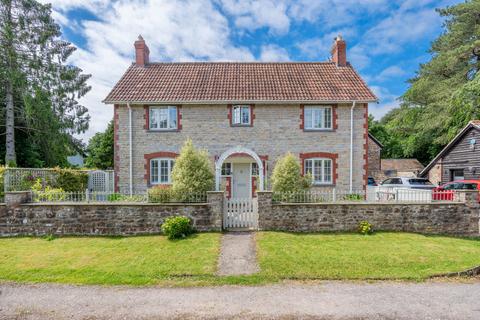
[[257, 232, 480, 280]]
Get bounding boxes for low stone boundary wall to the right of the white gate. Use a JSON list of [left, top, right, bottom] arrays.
[[258, 192, 480, 236]]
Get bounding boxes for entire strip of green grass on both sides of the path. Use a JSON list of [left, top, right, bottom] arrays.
[[0, 232, 480, 286]]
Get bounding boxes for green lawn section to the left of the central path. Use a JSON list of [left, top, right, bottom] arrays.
[[0, 233, 220, 285]]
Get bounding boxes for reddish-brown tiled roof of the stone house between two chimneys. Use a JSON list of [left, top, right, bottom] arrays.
[[104, 62, 377, 103]]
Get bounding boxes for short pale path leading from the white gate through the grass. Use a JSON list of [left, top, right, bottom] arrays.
[[218, 232, 260, 276]]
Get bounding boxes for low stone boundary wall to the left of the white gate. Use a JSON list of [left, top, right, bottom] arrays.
[[0, 193, 223, 236]]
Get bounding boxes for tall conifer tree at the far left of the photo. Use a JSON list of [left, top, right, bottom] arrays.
[[0, 0, 90, 166]]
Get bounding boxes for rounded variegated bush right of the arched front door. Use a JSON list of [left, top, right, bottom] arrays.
[[272, 152, 311, 193]]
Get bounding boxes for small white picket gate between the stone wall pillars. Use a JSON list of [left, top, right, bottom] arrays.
[[223, 198, 258, 229]]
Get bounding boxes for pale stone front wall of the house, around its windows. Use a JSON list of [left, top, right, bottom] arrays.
[[115, 104, 368, 191]]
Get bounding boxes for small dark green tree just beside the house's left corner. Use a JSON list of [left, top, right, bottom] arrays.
[[85, 121, 113, 169]]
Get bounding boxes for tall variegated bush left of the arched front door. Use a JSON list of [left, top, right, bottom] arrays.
[[172, 139, 215, 201]]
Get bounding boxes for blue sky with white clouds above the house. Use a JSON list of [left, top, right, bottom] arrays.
[[42, 0, 460, 139]]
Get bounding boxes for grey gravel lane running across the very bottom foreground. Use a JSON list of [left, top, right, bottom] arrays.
[[0, 281, 480, 320]]
